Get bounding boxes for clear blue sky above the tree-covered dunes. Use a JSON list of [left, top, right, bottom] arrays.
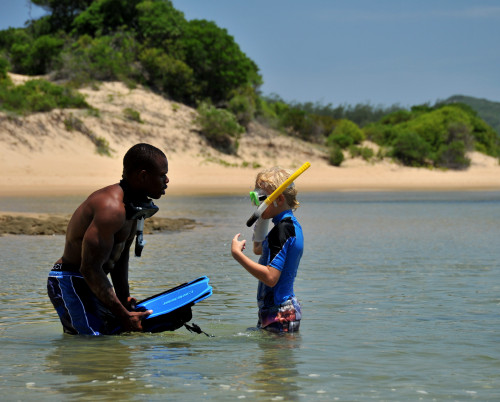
[[0, 0, 500, 106]]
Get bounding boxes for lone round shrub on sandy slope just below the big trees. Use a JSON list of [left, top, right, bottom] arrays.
[[195, 102, 245, 154]]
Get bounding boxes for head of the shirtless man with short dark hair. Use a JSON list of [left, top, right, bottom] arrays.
[[123, 143, 169, 199]]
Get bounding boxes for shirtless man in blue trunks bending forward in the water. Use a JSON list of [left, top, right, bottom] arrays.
[[47, 144, 169, 335]]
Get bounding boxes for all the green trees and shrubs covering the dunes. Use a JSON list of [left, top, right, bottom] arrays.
[[0, 0, 500, 169]]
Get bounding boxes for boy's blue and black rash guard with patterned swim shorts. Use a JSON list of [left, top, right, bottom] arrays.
[[257, 210, 304, 332]]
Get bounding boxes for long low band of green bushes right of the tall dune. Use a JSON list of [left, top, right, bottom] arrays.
[[258, 97, 500, 169]]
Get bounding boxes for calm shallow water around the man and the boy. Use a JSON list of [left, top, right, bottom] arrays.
[[0, 192, 500, 401]]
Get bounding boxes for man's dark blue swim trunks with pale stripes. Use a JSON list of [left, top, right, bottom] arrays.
[[47, 263, 121, 335]]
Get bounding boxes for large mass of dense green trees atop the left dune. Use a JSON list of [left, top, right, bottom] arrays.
[[0, 0, 262, 106]]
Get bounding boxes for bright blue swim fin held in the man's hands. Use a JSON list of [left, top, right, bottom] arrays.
[[136, 276, 212, 327]]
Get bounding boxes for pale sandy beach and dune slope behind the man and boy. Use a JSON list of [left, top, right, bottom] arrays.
[[0, 76, 500, 197]]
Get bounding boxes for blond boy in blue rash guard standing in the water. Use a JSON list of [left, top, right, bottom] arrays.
[[231, 167, 304, 332]]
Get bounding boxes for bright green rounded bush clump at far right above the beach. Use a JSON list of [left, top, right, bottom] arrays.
[[364, 103, 500, 169]]
